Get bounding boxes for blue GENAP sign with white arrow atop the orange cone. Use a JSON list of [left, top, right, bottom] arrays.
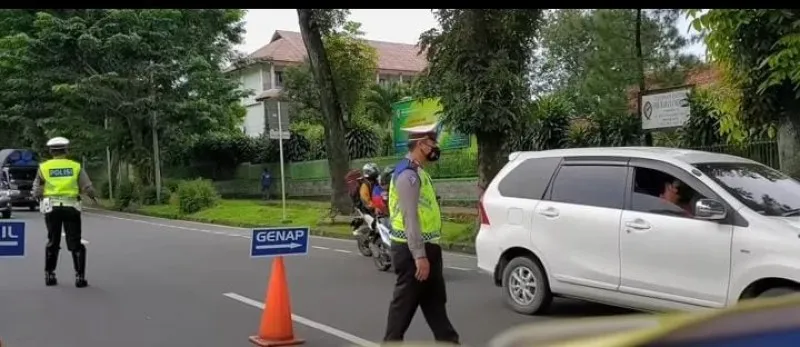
[[250, 227, 309, 257]]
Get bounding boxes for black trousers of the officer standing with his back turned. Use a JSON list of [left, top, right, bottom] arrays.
[[44, 206, 86, 276]]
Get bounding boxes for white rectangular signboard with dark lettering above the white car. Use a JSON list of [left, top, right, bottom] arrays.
[[642, 88, 691, 130]]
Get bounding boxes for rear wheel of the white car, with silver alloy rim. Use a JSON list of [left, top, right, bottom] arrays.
[[503, 257, 553, 315]]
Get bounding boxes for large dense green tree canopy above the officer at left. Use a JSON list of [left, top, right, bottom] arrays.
[[0, 10, 244, 188]]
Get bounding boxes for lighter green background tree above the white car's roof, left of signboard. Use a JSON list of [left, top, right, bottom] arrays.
[[532, 9, 700, 116]]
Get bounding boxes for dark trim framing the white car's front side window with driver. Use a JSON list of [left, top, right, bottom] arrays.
[[623, 158, 749, 227]]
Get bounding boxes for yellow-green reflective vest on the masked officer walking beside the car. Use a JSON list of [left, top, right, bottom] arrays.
[[389, 159, 442, 242]]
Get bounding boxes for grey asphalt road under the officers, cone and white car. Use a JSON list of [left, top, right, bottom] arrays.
[[0, 210, 627, 347]]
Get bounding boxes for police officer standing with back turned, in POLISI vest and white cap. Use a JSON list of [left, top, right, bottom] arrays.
[[33, 137, 97, 288]]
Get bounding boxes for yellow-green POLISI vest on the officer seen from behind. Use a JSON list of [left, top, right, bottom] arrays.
[[39, 159, 81, 205]]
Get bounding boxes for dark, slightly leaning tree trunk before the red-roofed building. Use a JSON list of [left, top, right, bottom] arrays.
[[297, 9, 352, 213]]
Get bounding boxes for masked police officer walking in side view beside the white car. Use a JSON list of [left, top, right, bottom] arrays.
[[384, 125, 459, 344]]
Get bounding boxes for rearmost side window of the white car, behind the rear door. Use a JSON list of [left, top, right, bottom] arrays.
[[497, 157, 561, 200]]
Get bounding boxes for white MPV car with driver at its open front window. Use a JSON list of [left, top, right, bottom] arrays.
[[475, 147, 800, 314]]
